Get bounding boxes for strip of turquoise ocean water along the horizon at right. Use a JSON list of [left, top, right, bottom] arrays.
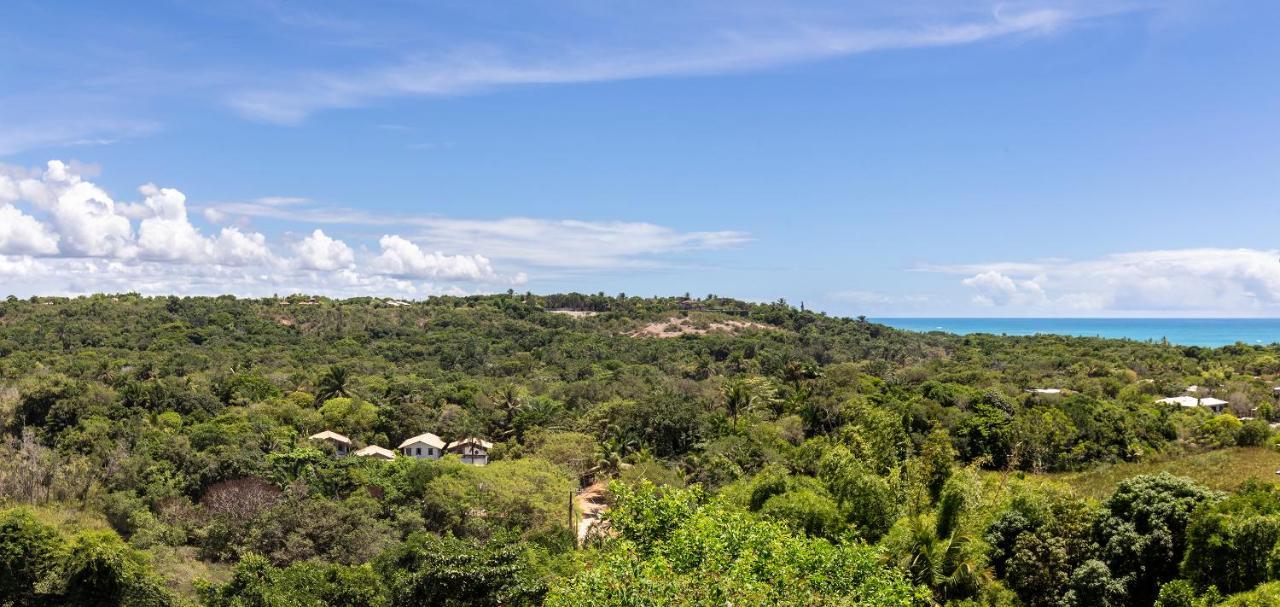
[[870, 318, 1280, 347]]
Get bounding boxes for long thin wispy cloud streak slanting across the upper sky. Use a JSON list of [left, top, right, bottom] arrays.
[[228, 8, 1088, 124]]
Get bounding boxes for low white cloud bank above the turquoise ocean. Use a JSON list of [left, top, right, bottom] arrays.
[[922, 248, 1280, 314]]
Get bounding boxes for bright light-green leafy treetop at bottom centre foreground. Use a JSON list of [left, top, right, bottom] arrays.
[[545, 483, 927, 607]]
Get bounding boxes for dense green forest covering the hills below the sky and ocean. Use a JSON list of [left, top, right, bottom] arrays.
[[0, 292, 1280, 607]]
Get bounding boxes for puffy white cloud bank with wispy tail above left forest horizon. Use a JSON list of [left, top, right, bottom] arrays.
[[0, 160, 748, 296]]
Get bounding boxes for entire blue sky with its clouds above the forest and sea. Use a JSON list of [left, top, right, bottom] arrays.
[[0, 0, 1280, 316]]
